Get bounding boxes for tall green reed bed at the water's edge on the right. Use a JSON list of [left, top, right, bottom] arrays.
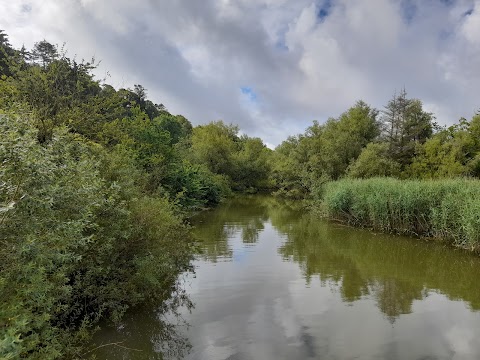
[[317, 178, 480, 251]]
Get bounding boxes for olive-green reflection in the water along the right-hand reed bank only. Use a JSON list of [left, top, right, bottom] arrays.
[[271, 208, 480, 321]]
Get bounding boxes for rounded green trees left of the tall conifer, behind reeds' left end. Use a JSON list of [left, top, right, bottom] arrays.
[[272, 101, 380, 197]]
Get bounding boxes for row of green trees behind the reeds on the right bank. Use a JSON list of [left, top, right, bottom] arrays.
[[272, 90, 480, 198]]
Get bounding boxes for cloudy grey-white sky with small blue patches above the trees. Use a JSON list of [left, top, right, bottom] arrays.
[[0, 0, 480, 146]]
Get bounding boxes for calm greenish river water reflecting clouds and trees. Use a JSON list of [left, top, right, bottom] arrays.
[[93, 196, 480, 360]]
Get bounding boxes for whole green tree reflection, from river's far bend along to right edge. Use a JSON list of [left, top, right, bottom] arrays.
[[195, 196, 480, 322]]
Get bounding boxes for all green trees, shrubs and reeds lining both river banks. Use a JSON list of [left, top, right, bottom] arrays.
[[0, 30, 480, 359]]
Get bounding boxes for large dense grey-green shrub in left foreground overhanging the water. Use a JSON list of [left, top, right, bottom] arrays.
[[0, 115, 191, 359]]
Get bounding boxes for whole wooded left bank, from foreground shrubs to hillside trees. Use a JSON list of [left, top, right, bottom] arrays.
[[0, 31, 271, 359]]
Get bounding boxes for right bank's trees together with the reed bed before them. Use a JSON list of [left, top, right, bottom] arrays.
[[272, 90, 480, 251]]
